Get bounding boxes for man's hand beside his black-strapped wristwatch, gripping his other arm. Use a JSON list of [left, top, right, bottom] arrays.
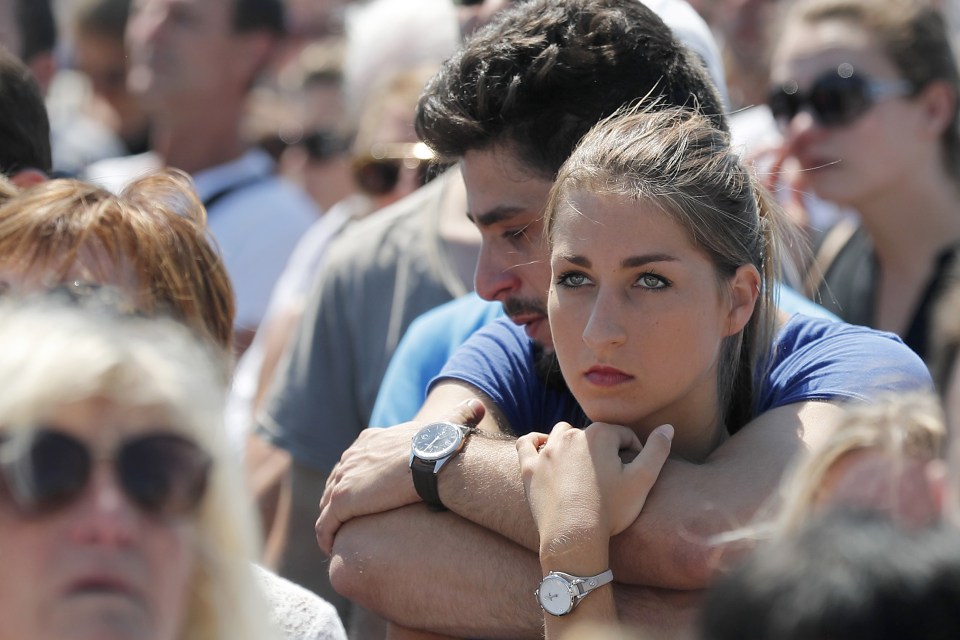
[[315, 400, 484, 555]]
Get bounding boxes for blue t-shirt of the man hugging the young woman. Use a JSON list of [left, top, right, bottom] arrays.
[[430, 314, 933, 435]]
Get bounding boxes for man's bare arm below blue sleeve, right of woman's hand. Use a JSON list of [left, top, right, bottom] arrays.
[[610, 402, 842, 590]]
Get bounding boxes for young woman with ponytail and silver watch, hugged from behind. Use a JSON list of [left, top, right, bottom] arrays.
[[517, 102, 803, 635]]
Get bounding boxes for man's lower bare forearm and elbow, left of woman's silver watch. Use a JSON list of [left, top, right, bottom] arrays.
[[330, 505, 543, 638]]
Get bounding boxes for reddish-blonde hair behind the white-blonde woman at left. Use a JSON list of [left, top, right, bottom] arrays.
[[0, 170, 235, 348]]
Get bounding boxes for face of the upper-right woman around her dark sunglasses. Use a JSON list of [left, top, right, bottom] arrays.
[[770, 19, 939, 208]]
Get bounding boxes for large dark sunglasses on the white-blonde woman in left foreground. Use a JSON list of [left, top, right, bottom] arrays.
[[0, 428, 212, 517]]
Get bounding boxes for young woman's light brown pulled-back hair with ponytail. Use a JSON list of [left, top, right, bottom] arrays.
[[544, 103, 789, 433]]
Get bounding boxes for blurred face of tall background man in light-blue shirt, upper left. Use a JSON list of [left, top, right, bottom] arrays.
[[127, 0, 242, 106]]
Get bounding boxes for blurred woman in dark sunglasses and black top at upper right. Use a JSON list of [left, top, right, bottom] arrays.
[[769, 0, 960, 359]]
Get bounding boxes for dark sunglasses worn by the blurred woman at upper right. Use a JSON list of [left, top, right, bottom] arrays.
[[767, 63, 914, 127]]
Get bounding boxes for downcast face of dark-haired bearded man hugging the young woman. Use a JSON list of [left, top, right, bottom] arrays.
[[461, 146, 553, 347]]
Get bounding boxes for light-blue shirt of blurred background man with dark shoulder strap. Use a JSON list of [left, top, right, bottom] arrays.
[[86, 149, 320, 329]]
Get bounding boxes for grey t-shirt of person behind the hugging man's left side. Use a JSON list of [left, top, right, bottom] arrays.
[[257, 172, 469, 472]]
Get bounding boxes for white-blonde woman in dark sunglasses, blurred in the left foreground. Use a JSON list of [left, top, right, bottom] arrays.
[[0, 300, 276, 640]]
